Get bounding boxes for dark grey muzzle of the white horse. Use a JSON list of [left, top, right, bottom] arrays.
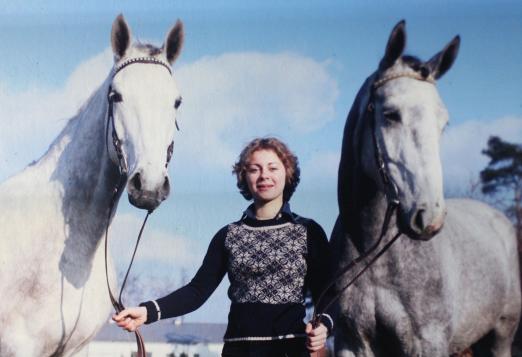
[[127, 172, 170, 211]]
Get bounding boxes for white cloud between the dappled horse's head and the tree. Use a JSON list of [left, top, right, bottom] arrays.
[[441, 116, 522, 192]]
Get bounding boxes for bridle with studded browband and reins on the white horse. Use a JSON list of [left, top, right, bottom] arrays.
[[105, 57, 179, 357]]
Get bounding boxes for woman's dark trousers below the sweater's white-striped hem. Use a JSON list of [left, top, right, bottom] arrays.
[[221, 338, 310, 357]]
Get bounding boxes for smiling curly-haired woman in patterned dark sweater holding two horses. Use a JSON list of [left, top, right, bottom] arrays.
[[113, 138, 333, 357]]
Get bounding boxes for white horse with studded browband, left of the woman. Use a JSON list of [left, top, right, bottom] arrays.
[[0, 15, 183, 357]]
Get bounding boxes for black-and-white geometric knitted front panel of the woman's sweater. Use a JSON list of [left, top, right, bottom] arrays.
[[225, 222, 307, 304]]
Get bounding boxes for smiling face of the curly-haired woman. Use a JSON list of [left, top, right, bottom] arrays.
[[246, 149, 286, 203]]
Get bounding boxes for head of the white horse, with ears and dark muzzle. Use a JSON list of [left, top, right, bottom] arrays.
[[107, 15, 183, 211]]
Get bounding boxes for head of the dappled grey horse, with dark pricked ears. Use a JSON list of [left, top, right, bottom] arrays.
[[362, 21, 460, 240]]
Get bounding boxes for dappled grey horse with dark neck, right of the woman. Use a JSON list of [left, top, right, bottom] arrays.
[[331, 21, 521, 357]]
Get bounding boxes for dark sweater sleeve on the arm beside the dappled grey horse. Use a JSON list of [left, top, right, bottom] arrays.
[[306, 220, 337, 333]]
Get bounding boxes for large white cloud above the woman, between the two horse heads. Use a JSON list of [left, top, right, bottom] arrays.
[[175, 53, 338, 168]]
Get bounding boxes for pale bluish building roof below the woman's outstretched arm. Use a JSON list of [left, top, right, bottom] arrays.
[[94, 319, 227, 344]]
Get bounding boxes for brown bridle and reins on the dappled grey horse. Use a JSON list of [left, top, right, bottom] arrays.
[[312, 72, 435, 326]]
